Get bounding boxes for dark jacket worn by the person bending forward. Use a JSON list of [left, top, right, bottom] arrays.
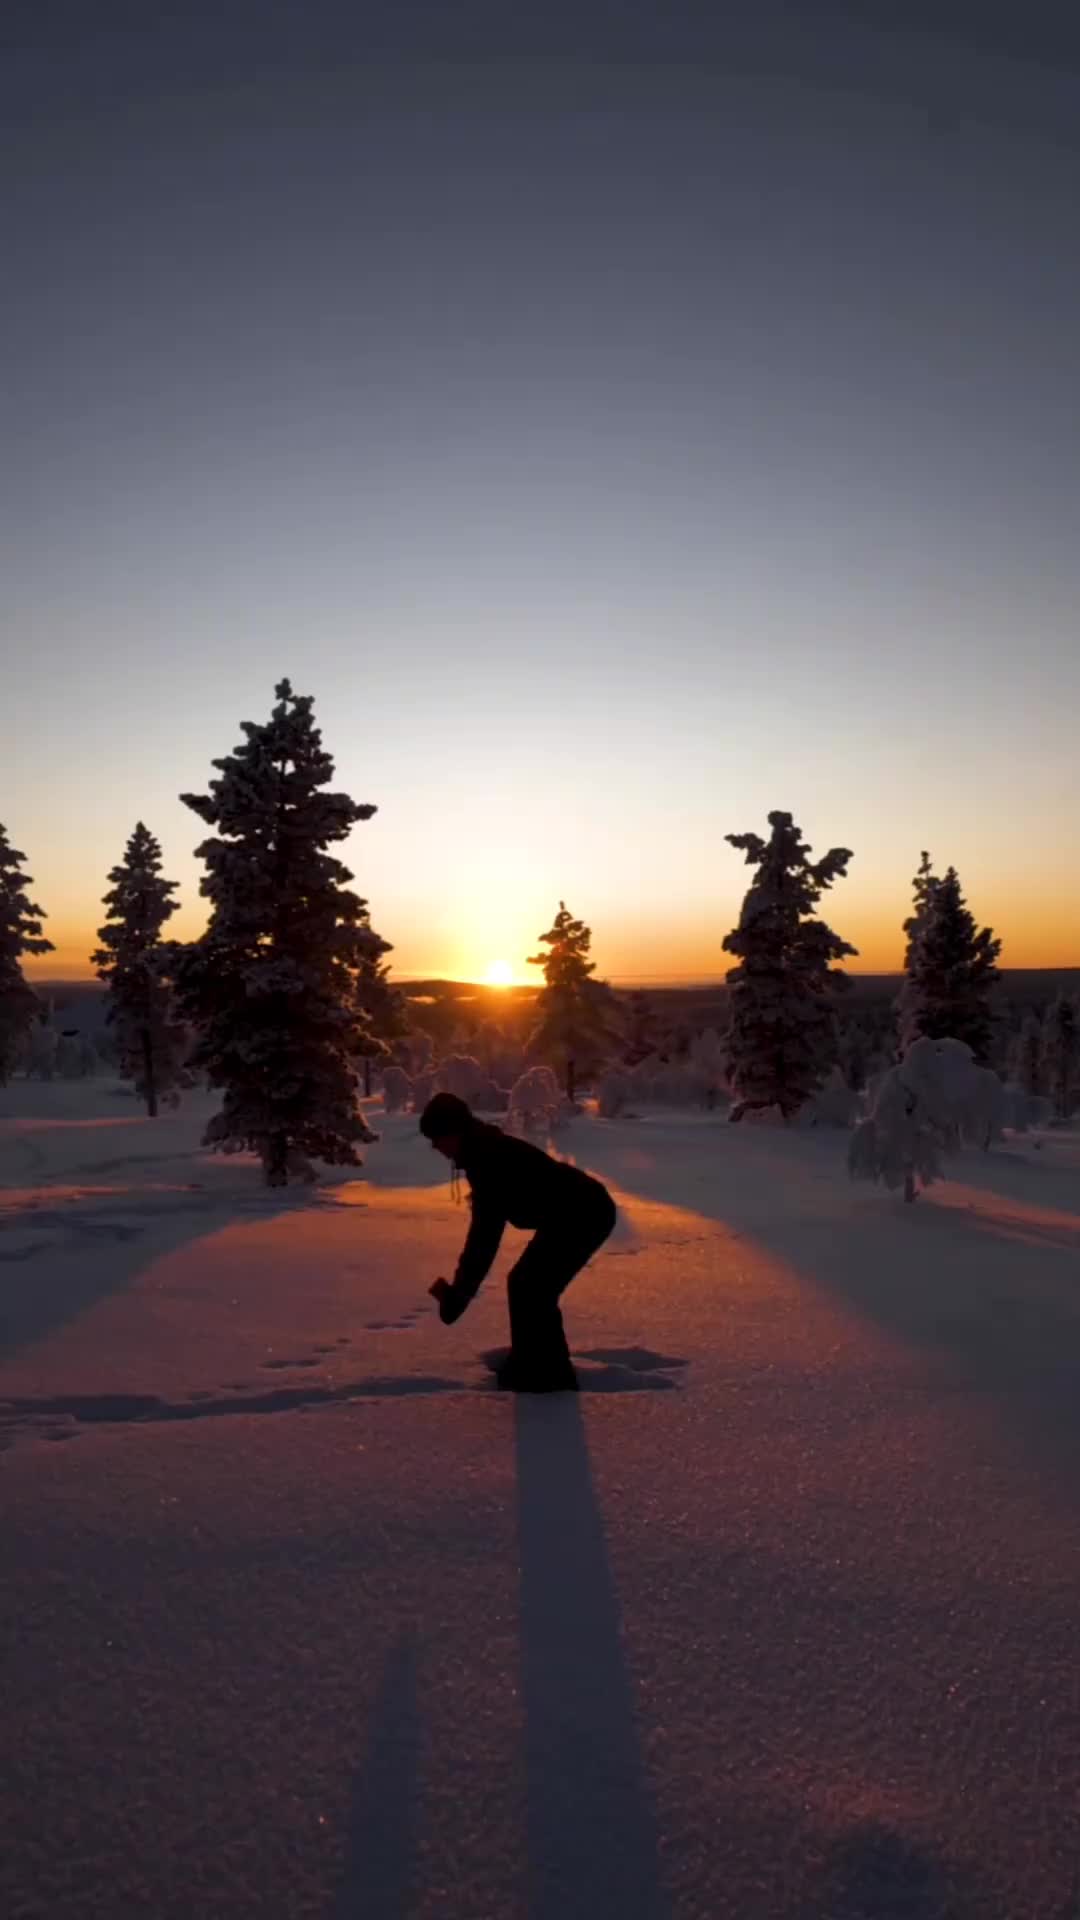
[[454, 1121, 611, 1309]]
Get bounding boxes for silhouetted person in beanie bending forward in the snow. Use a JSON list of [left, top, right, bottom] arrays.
[[421, 1092, 615, 1394]]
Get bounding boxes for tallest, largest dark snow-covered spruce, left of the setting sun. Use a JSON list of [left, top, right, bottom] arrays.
[[177, 680, 375, 1187]]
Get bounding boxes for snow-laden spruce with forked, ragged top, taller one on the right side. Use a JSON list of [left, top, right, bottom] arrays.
[[724, 812, 855, 1119]]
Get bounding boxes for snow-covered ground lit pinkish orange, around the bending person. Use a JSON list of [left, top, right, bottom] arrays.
[[0, 1081, 1080, 1920]]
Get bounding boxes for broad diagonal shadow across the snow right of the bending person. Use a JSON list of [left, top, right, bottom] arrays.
[[594, 1125, 1080, 1498]]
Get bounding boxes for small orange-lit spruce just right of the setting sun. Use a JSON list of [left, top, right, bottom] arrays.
[[528, 900, 619, 1100]]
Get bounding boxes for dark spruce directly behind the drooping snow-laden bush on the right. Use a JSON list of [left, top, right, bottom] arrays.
[[897, 854, 1001, 1066]]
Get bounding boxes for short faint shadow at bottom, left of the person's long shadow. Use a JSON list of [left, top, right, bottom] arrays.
[[332, 1636, 421, 1920]]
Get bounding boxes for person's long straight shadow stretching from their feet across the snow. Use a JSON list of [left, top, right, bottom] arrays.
[[515, 1396, 669, 1920]]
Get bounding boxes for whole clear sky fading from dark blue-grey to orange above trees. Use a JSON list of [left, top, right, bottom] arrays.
[[8, 0, 1080, 979]]
